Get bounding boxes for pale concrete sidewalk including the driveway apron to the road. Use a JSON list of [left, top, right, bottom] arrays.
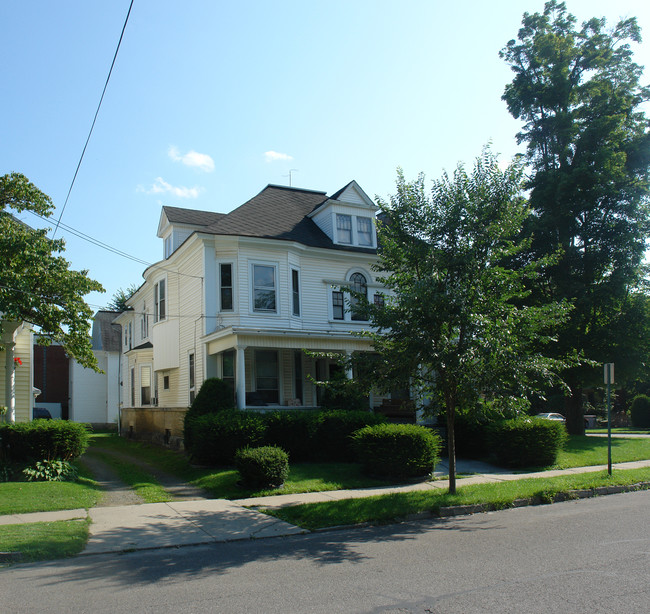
[[0, 460, 650, 555]]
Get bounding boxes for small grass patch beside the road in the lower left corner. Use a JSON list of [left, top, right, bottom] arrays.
[[0, 520, 88, 567]]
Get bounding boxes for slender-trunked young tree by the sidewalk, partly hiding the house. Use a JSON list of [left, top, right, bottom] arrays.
[[363, 150, 567, 492]]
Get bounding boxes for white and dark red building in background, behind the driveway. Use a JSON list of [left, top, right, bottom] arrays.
[[34, 311, 122, 426]]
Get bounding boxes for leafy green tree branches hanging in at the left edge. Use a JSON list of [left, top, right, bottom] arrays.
[[0, 173, 103, 368]]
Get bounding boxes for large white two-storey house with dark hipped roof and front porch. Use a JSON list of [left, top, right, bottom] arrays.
[[116, 181, 390, 440]]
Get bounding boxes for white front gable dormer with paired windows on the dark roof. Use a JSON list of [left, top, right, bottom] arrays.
[[309, 181, 378, 249]]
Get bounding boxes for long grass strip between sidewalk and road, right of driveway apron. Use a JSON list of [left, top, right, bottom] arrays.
[[265, 468, 650, 530]]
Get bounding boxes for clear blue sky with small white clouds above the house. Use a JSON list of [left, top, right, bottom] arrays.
[[0, 0, 650, 307]]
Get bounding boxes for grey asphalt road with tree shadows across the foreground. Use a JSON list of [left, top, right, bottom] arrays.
[[0, 491, 650, 614]]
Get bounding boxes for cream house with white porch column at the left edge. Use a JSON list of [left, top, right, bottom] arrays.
[[0, 322, 34, 422]]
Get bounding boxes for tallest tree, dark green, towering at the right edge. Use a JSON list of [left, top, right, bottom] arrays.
[[501, 1, 650, 434]]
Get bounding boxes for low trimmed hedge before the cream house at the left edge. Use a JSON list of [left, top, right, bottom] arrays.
[[0, 420, 89, 462]]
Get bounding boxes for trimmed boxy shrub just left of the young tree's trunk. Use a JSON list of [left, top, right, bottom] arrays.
[[352, 424, 442, 478]]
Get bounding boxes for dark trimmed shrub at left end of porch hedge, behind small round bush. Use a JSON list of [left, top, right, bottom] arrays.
[[185, 409, 265, 465]]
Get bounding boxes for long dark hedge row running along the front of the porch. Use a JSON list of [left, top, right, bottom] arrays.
[[185, 410, 386, 465]]
